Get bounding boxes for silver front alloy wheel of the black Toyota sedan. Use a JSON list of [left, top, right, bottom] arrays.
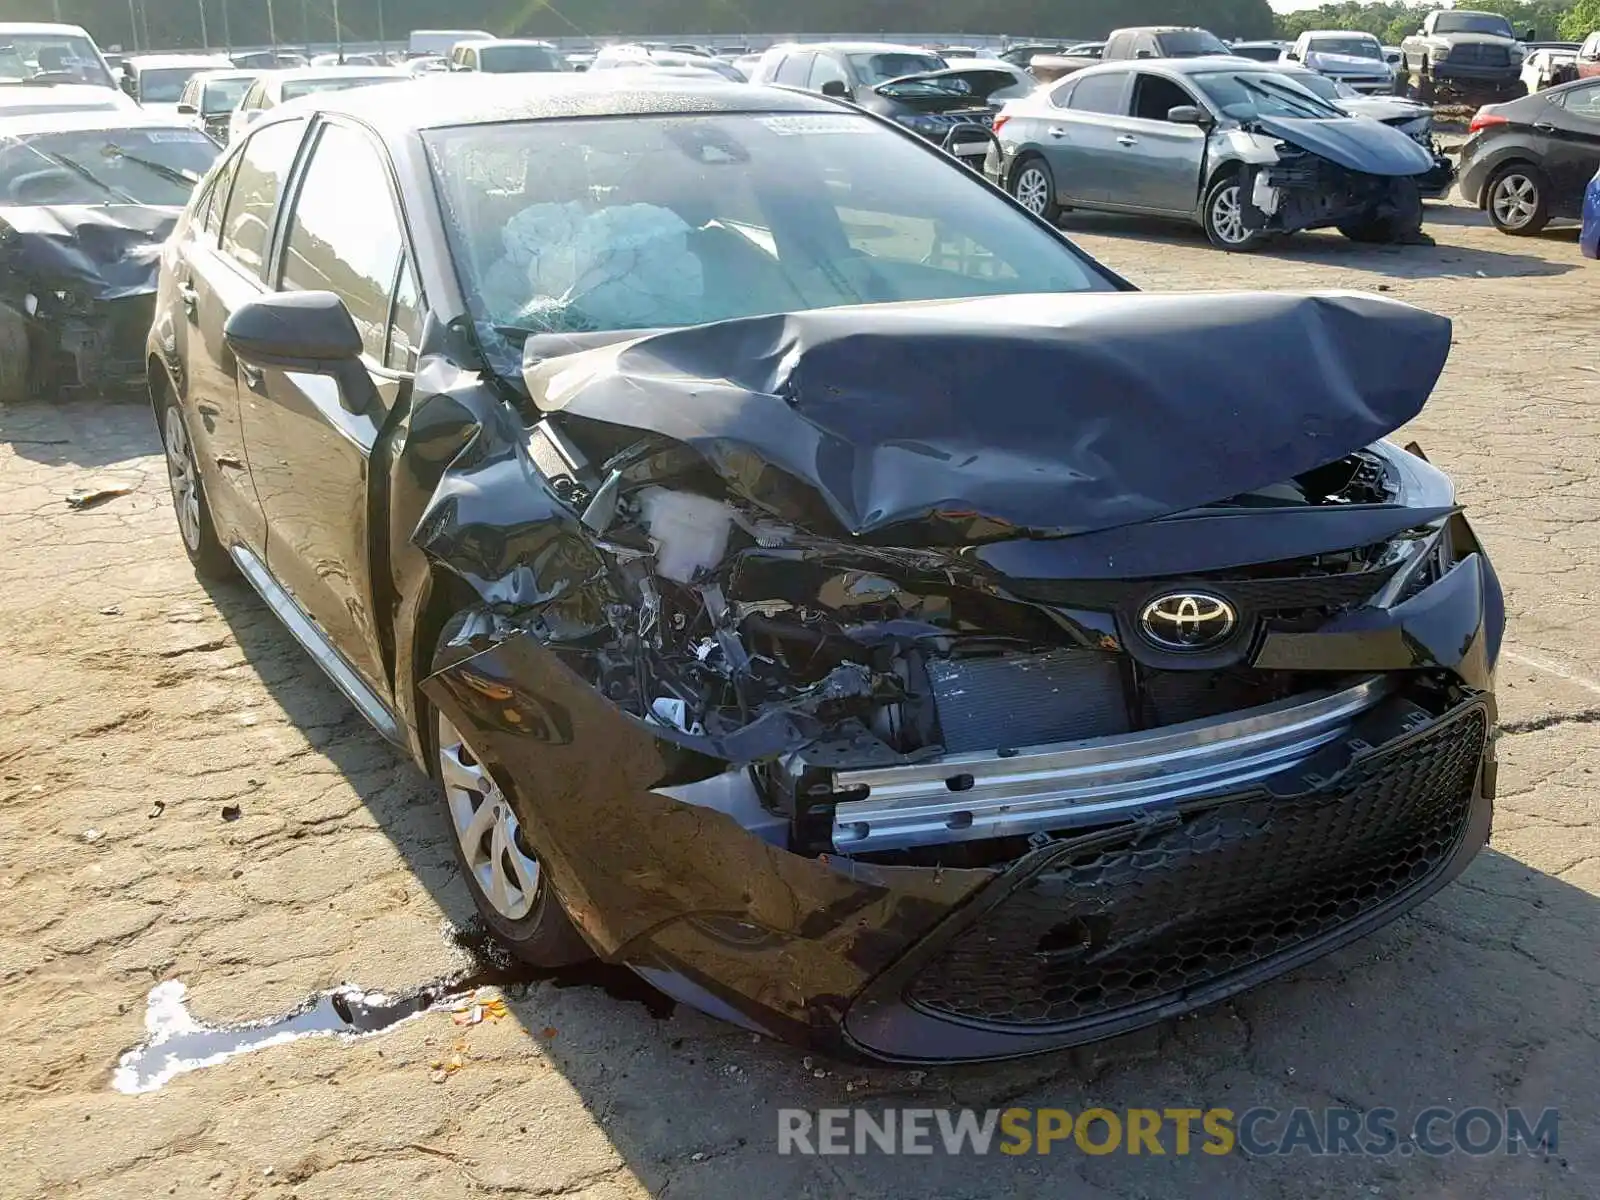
[[438, 714, 539, 920]]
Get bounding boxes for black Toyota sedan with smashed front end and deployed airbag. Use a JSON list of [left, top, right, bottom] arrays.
[[149, 75, 1504, 1061]]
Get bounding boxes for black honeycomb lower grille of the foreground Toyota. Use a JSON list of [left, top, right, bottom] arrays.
[[906, 706, 1488, 1029]]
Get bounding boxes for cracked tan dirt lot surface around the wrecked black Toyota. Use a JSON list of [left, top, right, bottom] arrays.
[[0, 206, 1600, 1200]]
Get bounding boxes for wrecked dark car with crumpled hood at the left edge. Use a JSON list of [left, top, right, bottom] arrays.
[[0, 112, 218, 402]]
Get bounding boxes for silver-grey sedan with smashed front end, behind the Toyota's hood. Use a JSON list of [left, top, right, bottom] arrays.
[[986, 58, 1435, 250]]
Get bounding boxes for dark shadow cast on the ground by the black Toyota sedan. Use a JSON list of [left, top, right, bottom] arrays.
[[175, 582, 1600, 1198]]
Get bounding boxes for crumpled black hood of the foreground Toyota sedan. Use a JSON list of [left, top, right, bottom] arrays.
[[523, 293, 1450, 546]]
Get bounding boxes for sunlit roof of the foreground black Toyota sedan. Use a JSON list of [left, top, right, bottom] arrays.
[[282, 70, 843, 141]]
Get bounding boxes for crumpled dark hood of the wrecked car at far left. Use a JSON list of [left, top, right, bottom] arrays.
[[0, 205, 182, 301]]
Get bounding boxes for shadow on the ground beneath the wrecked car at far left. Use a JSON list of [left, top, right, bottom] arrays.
[[0, 392, 162, 467]]
